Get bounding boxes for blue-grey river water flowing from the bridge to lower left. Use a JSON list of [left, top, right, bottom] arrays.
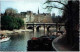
[[0, 30, 56, 51]]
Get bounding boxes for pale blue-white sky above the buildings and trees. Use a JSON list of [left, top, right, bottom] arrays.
[[1, 0, 67, 16]]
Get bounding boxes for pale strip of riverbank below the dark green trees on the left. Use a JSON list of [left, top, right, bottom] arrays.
[[0, 29, 33, 34]]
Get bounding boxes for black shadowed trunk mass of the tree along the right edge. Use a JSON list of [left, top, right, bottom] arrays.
[[65, 1, 79, 50]]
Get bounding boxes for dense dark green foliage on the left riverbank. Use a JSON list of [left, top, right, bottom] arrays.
[[1, 16, 24, 30]]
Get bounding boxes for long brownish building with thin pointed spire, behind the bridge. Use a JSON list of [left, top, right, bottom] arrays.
[[34, 8, 52, 23]]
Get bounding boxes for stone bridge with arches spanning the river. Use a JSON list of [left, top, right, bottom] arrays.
[[25, 23, 65, 31]]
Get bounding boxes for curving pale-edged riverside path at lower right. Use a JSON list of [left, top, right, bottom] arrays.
[[52, 35, 78, 51]]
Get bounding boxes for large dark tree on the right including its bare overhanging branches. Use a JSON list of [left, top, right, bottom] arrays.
[[45, 0, 79, 50]]
